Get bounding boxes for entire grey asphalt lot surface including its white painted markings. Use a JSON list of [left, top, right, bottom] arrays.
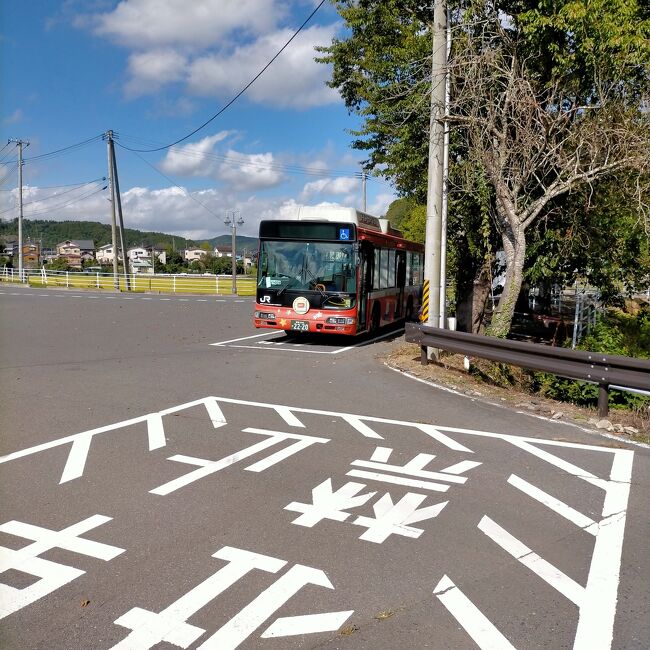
[[0, 285, 650, 650]]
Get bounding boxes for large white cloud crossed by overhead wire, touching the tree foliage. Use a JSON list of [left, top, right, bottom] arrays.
[[188, 25, 339, 108]]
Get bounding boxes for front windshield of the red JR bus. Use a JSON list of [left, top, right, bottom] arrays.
[[257, 240, 356, 293]]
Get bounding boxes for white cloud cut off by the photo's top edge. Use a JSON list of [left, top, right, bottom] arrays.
[[94, 0, 284, 50]]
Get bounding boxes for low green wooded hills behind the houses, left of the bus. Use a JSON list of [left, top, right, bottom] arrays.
[[0, 219, 257, 250]]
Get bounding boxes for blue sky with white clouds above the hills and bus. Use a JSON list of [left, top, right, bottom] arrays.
[[0, 0, 394, 238]]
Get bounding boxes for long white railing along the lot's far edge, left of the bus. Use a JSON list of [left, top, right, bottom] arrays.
[[0, 268, 255, 296]]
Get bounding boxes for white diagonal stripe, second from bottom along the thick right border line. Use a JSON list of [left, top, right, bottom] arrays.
[[478, 515, 585, 607]]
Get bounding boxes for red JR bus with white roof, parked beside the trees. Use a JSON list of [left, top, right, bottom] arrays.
[[254, 207, 424, 335]]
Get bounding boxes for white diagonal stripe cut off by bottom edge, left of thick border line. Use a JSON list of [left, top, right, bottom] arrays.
[[433, 576, 515, 650]]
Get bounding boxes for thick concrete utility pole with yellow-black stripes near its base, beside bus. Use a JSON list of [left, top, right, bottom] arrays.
[[422, 0, 447, 361]]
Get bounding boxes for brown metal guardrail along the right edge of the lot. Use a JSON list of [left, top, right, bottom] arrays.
[[405, 323, 650, 417]]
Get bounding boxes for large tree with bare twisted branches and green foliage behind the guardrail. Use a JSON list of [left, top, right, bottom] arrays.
[[320, 0, 650, 335]]
